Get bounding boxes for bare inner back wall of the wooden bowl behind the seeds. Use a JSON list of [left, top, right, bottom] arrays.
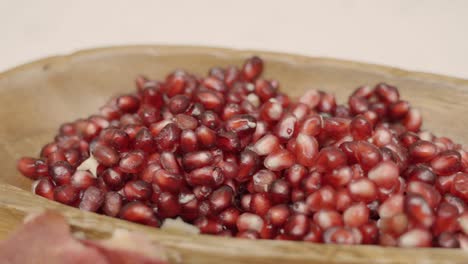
[[0, 46, 468, 190]]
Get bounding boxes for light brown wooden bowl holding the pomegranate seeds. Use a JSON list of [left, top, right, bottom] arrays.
[[0, 46, 468, 263]]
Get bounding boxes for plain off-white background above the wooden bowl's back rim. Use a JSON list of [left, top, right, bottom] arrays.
[[0, 0, 468, 79]]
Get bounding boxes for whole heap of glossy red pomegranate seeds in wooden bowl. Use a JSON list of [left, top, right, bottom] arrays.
[[18, 57, 468, 248]]
